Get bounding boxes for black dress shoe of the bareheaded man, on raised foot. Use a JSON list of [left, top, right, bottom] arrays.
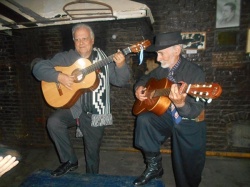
[[51, 161, 78, 177]]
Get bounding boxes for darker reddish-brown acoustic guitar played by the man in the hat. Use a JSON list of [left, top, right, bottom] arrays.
[[133, 78, 222, 116]]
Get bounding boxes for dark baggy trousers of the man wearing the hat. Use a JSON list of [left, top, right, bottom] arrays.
[[135, 112, 206, 187]]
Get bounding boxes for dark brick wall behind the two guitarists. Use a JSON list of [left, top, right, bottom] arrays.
[[0, 0, 250, 152]]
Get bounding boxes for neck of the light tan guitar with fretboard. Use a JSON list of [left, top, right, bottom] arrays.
[[82, 47, 131, 75]]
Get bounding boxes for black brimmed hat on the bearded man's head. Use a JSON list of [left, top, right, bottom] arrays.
[[146, 31, 184, 52]]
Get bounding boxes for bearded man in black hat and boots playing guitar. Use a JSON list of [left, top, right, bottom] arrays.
[[133, 32, 206, 187]]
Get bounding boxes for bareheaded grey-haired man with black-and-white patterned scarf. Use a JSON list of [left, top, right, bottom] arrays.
[[33, 24, 130, 176]]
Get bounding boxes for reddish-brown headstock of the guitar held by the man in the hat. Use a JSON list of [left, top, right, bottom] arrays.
[[187, 83, 222, 102]]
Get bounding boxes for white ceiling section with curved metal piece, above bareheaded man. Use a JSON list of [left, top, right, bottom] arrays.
[[0, 0, 154, 30]]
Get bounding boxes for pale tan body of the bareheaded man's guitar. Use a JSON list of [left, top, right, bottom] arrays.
[[41, 58, 99, 108]]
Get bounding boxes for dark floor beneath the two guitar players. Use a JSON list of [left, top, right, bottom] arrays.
[[0, 147, 250, 187]]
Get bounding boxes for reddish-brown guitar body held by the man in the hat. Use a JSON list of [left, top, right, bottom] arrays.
[[133, 78, 172, 116]]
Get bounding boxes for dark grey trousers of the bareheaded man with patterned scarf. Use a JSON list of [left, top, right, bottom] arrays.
[[47, 109, 104, 173]]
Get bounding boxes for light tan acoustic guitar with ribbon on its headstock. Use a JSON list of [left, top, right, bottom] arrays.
[[41, 40, 151, 108]]
